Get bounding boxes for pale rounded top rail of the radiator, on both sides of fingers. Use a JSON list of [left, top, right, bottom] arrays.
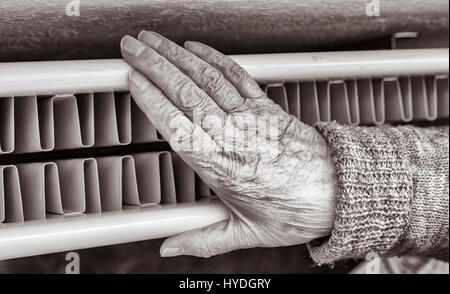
[[0, 48, 449, 97]]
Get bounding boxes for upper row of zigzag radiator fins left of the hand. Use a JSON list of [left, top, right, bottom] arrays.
[[0, 92, 161, 154]]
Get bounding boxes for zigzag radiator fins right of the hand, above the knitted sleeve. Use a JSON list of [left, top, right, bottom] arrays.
[[263, 75, 449, 125]]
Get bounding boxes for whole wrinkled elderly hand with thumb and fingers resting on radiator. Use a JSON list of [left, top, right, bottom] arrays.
[[121, 32, 335, 257]]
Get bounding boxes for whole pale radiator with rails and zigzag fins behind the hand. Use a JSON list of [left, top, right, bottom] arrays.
[[0, 49, 449, 259]]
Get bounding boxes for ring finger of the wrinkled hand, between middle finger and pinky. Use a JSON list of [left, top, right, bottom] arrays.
[[138, 31, 244, 112]]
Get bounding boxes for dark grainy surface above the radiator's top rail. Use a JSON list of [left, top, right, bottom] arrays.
[[0, 0, 449, 61]]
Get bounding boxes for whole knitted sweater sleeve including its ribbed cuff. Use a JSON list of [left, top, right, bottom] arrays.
[[308, 122, 449, 264]]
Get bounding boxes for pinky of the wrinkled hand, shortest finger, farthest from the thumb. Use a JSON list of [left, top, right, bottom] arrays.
[[184, 41, 266, 99]]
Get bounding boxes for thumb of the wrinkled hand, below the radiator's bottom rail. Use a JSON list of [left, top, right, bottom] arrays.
[[160, 218, 251, 257]]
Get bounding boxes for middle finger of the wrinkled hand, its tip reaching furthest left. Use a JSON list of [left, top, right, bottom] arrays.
[[121, 36, 225, 119]]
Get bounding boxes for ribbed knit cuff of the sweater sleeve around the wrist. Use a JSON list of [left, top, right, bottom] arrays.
[[308, 122, 413, 264]]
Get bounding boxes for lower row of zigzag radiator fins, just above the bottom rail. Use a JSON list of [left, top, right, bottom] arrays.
[[0, 151, 212, 223]]
